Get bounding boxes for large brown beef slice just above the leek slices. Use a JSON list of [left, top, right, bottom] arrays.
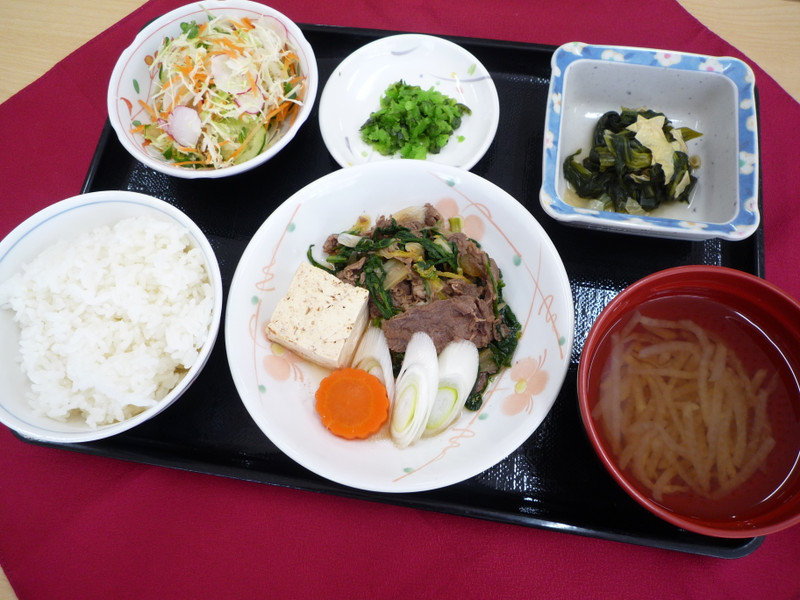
[[382, 296, 496, 352]]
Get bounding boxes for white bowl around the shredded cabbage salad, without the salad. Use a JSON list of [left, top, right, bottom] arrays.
[[106, 0, 319, 179]]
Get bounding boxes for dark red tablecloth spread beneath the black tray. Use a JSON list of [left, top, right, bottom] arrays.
[[0, 0, 800, 600]]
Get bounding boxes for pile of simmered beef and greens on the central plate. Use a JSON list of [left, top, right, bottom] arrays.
[[307, 204, 522, 410]]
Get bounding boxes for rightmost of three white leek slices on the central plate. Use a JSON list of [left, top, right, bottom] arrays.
[[425, 340, 478, 435]]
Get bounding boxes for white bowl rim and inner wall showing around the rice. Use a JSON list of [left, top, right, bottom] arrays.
[[0, 191, 223, 443]]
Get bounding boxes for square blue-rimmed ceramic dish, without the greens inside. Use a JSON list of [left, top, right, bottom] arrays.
[[540, 42, 760, 241]]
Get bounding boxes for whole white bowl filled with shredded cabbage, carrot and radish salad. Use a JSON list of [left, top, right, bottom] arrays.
[[108, 0, 318, 178]]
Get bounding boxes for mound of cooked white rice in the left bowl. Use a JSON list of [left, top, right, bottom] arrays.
[[0, 217, 214, 427]]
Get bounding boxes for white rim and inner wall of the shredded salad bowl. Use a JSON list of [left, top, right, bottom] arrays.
[[107, 0, 319, 179]]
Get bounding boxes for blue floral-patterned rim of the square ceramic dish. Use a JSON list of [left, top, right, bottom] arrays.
[[540, 42, 760, 240]]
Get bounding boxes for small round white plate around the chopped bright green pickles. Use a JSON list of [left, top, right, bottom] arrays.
[[319, 34, 500, 169]]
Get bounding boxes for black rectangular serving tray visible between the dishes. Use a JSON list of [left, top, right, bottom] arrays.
[[23, 25, 763, 558]]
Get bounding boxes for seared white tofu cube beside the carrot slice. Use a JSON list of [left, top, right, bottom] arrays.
[[266, 262, 369, 369]]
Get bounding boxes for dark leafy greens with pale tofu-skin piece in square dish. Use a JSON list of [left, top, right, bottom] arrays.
[[563, 108, 702, 213]]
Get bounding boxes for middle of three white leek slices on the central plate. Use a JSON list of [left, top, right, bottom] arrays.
[[389, 331, 439, 448]]
